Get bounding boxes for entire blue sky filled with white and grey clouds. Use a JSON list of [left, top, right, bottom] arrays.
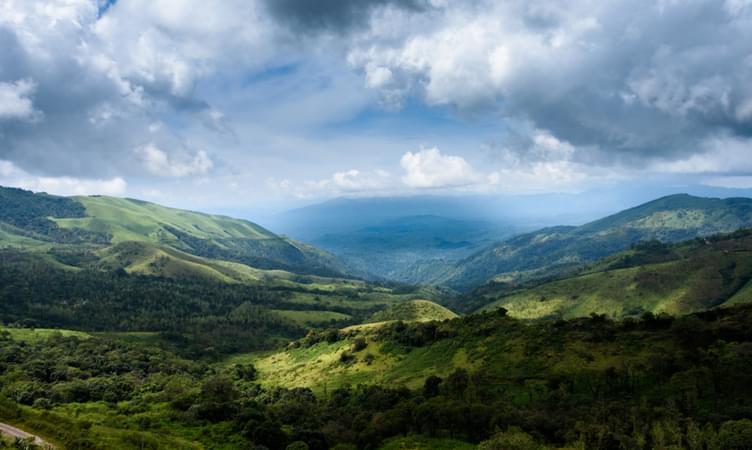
[[0, 0, 752, 214]]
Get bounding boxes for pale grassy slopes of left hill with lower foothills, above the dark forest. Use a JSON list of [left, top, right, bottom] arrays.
[[0, 188, 436, 326]]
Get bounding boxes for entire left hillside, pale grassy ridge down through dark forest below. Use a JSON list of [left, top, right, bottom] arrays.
[[0, 188, 442, 358]]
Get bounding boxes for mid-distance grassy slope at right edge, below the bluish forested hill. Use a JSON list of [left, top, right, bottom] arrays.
[[478, 233, 752, 319]]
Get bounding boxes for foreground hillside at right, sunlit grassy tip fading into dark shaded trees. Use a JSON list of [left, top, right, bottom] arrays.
[[231, 305, 752, 449]]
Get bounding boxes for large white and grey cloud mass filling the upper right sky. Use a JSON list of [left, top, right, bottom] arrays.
[[348, 0, 752, 166]]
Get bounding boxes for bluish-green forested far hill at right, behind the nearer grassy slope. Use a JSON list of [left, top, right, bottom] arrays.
[[436, 194, 752, 291]]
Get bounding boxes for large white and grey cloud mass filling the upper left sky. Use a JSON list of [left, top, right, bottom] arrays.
[[0, 0, 280, 178]]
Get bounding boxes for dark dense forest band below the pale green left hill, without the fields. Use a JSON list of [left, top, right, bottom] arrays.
[[0, 250, 304, 355]]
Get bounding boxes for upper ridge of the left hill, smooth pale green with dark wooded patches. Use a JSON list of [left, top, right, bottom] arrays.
[[0, 187, 343, 275]]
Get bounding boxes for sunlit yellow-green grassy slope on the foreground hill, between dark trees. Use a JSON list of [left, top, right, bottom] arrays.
[[244, 302, 720, 393]]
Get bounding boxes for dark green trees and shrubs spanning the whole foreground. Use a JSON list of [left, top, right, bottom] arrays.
[[0, 306, 752, 450]]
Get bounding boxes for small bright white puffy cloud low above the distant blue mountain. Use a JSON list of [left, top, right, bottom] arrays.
[[400, 147, 476, 188]]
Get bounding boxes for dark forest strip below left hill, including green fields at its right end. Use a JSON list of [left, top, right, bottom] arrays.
[[0, 249, 429, 357]]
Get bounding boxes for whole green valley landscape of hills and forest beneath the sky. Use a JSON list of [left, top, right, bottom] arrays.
[[0, 188, 752, 450]]
